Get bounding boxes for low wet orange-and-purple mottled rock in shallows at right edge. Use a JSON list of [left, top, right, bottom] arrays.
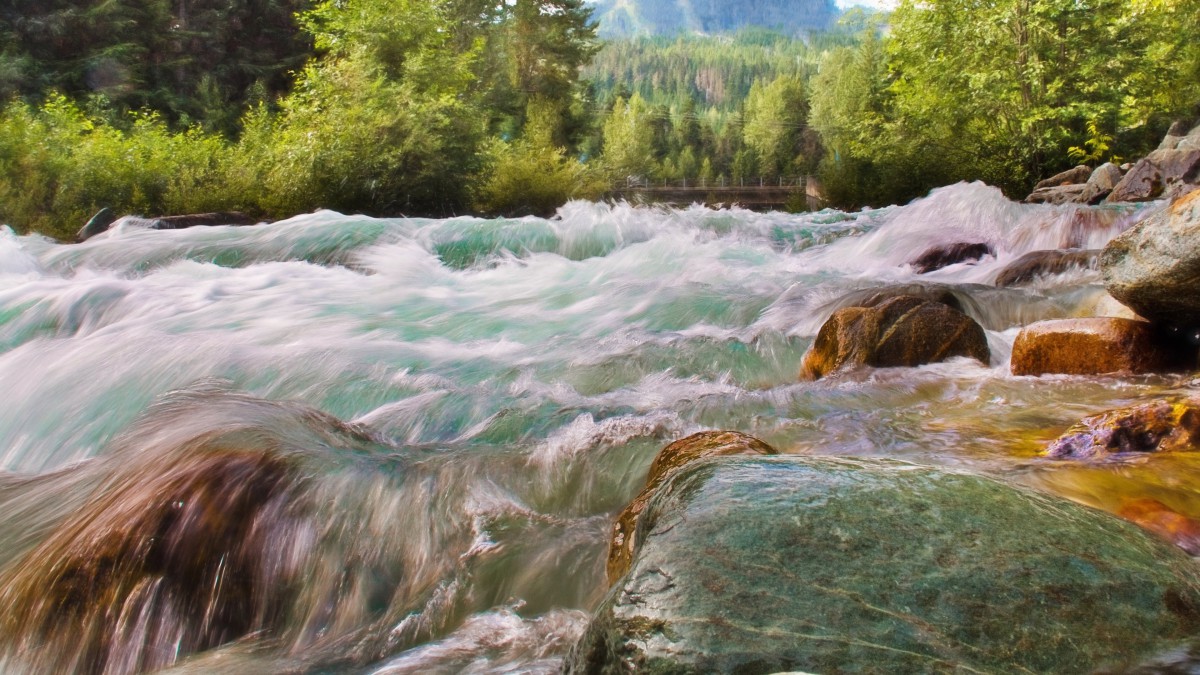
[[1045, 399, 1200, 459]]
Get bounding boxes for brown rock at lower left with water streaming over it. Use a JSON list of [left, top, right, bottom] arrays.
[[0, 449, 299, 674]]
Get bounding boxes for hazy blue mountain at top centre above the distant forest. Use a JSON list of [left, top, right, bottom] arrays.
[[594, 0, 839, 37]]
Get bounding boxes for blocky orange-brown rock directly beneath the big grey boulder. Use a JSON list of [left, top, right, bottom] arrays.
[[1012, 317, 1195, 376]]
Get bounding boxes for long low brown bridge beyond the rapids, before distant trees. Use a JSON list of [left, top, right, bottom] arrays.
[[605, 177, 826, 211]]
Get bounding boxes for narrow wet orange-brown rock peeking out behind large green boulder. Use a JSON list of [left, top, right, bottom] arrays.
[[607, 431, 779, 584]]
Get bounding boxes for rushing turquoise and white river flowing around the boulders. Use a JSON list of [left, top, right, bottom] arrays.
[[0, 184, 1200, 674]]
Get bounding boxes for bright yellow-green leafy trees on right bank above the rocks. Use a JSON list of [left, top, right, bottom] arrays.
[[812, 0, 1200, 204]]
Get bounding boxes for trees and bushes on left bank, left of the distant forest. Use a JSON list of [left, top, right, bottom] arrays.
[[0, 0, 593, 238]]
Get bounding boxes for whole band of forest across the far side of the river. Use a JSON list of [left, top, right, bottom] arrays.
[[0, 0, 1200, 238]]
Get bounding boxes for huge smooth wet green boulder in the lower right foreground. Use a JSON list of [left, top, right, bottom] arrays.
[[564, 456, 1200, 675]]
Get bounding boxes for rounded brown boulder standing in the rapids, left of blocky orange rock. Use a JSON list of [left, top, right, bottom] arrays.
[[800, 295, 990, 380]]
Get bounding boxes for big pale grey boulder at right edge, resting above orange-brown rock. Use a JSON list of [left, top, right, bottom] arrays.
[[1100, 190, 1200, 327]]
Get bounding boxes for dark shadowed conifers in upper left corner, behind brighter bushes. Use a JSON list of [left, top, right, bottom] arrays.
[[0, 0, 311, 133]]
